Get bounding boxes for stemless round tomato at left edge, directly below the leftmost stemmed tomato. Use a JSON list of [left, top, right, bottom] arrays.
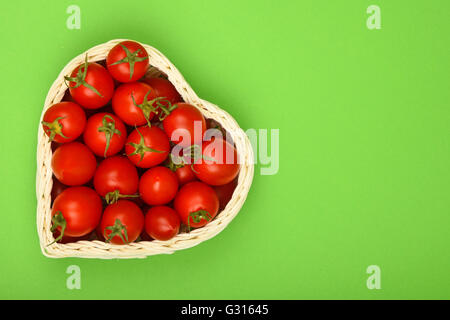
[[52, 142, 97, 186]]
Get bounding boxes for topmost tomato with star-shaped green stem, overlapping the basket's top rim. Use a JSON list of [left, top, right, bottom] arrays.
[[106, 41, 149, 82]]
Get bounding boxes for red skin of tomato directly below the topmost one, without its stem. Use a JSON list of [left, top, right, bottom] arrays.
[[112, 82, 156, 126]]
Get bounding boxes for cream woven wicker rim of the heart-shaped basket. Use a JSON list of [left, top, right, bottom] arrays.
[[36, 39, 253, 259]]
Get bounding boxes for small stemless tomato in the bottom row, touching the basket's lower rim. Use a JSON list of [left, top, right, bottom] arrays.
[[145, 206, 180, 241]]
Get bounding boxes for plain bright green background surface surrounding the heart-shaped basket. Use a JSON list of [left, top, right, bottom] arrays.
[[0, 0, 450, 299]]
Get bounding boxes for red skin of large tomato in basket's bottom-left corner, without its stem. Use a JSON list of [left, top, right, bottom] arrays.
[[52, 187, 102, 237]]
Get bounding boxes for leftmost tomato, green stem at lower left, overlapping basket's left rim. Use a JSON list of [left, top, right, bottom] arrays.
[[42, 102, 86, 143]]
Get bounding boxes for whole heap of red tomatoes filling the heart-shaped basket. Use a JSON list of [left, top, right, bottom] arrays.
[[42, 41, 240, 244]]
